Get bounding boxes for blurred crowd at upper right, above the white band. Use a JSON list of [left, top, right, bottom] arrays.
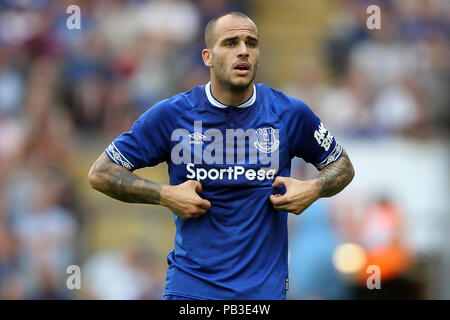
[[286, 0, 450, 138]]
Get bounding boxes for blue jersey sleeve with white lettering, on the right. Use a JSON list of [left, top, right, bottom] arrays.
[[286, 98, 343, 170]]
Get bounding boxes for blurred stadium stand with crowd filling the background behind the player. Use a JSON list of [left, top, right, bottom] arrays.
[[0, 0, 450, 299]]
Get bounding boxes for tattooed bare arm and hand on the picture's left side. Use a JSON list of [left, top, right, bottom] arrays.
[[88, 153, 211, 219]]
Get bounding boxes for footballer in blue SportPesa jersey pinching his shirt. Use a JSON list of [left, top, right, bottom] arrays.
[[89, 12, 354, 300]]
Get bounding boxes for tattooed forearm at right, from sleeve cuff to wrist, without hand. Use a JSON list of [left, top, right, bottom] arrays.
[[315, 150, 355, 198]]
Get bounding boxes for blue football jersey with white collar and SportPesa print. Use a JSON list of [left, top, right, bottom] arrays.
[[105, 83, 342, 299]]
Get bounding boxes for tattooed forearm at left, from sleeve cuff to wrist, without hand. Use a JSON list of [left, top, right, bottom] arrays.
[[89, 154, 162, 204]]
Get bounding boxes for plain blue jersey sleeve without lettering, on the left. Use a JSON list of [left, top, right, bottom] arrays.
[[105, 101, 173, 171]]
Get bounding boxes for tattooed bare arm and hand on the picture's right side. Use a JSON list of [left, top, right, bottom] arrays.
[[270, 151, 355, 214]]
